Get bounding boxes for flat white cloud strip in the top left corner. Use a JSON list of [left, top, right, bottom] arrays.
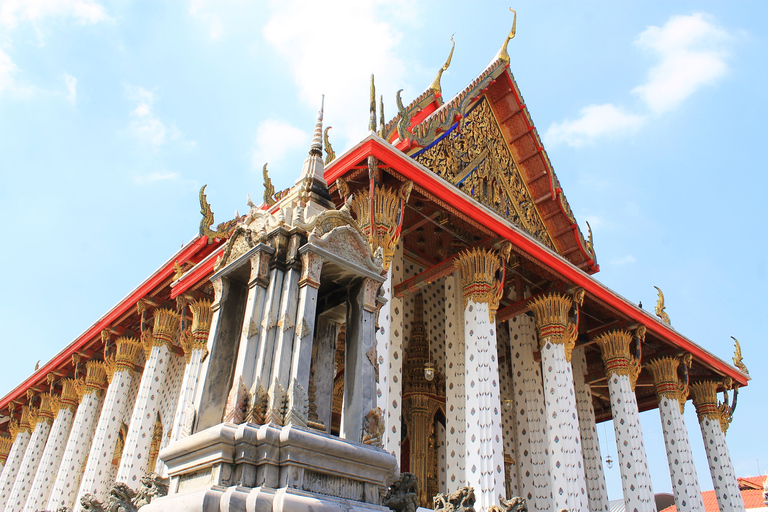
[[0, 0, 111, 28]]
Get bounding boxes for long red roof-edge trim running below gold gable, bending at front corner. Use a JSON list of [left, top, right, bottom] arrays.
[[325, 135, 748, 386]]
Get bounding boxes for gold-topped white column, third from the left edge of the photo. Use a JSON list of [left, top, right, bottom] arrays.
[[5, 393, 53, 512]]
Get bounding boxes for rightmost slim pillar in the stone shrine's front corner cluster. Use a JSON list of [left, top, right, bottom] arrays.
[[285, 246, 324, 428]]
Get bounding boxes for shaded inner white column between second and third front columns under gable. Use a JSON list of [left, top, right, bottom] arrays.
[[573, 349, 608, 512]]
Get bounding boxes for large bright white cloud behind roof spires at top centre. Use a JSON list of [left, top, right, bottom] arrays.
[[264, 0, 414, 153]]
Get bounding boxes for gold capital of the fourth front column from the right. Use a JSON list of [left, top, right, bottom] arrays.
[[531, 289, 584, 361]]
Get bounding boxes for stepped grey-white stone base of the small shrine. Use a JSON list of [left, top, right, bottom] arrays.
[[150, 423, 396, 512]]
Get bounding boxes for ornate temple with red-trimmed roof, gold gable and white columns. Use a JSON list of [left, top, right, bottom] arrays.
[[0, 15, 749, 512]]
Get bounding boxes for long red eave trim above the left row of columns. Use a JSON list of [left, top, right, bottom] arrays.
[[0, 237, 220, 410]]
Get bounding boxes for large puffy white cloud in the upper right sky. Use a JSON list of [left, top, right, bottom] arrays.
[[632, 13, 729, 114]]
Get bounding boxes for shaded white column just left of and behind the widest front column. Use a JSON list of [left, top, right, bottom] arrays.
[[440, 271, 467, 492]]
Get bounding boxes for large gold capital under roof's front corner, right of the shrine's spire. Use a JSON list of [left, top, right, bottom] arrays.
[[337, 175, 413, 272]]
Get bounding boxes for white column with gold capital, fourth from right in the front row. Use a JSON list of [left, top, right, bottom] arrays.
[[531, 290, 587, 511]]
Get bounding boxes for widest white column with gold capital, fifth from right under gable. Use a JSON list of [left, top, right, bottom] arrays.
[[456, 249, 508, 512]]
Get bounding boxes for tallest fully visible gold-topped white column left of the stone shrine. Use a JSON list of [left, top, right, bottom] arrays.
[[115, 309, 179, 489]]
